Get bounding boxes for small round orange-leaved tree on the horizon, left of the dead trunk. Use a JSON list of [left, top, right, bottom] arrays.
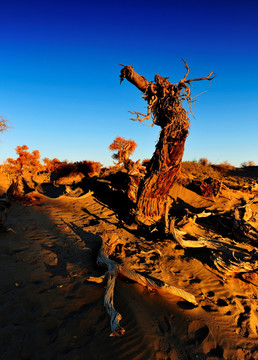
[[109, 136, 137, 164]]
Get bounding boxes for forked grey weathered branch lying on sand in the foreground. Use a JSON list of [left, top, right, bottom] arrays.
[[87, 233, 197, 336]]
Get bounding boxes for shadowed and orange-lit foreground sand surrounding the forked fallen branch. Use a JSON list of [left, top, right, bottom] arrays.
[[0, 184, 258, 360]]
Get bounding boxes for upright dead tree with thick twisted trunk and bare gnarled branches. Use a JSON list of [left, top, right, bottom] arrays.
[[120, 60, 215, 226]]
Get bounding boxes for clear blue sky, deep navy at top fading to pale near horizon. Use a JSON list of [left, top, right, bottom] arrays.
[[0, 0, 258, 166]]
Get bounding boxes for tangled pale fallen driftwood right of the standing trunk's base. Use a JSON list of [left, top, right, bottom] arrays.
[[169, 196, 258, 276]]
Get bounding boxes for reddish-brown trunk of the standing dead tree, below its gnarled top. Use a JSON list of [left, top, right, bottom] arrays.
[[136, 108, 189, 226]]
